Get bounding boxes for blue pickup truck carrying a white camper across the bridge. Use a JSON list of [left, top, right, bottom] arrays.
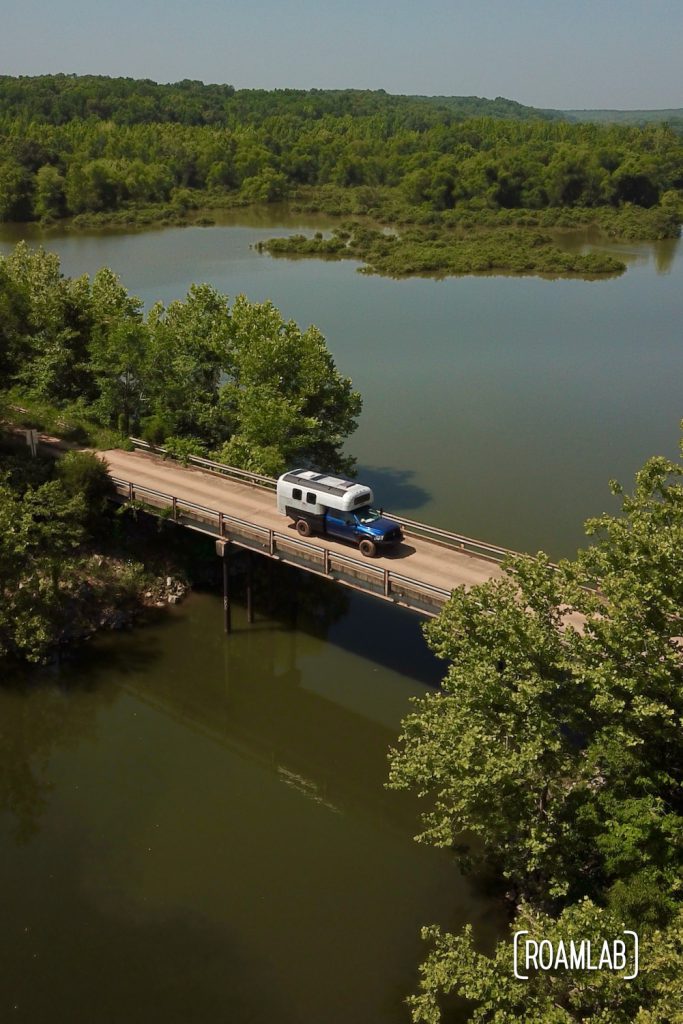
[[278, 469, 403, 558]]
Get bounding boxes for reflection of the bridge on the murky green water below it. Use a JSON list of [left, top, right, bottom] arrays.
[[107, 585, 442, 835]]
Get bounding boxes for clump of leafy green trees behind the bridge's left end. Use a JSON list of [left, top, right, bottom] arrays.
[[0, 244, 361, 474]]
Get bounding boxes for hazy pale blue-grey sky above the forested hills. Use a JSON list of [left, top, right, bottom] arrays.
[[0, 0, 683, 109]]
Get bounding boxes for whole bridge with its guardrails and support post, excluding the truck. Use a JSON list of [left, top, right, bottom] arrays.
[[97, 439, 513, 628]]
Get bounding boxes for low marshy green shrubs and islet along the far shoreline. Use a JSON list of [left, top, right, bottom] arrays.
[[4, 188, 681, 281]]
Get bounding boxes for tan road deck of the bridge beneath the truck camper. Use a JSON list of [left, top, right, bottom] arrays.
[[98, 449, 502, 613]]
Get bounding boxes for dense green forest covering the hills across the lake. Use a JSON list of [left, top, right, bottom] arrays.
[[0, 76, 683, 273]]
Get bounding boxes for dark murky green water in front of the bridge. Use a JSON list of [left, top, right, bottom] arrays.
[[0, 593, 501, 1024]]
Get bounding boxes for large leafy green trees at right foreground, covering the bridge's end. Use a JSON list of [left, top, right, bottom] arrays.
[[391, 448, 683, 1024]]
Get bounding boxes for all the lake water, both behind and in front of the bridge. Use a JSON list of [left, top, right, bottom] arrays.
[[0, 211, 683, 1024]]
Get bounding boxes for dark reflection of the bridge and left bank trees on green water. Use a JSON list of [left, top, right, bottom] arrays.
[[0, 544, 442, 856]]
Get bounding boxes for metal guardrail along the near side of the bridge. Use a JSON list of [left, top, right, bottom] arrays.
[[111, 476, 451, 612]]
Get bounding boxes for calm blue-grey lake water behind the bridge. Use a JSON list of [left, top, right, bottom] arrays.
[[0, 211, 683, 557]]
